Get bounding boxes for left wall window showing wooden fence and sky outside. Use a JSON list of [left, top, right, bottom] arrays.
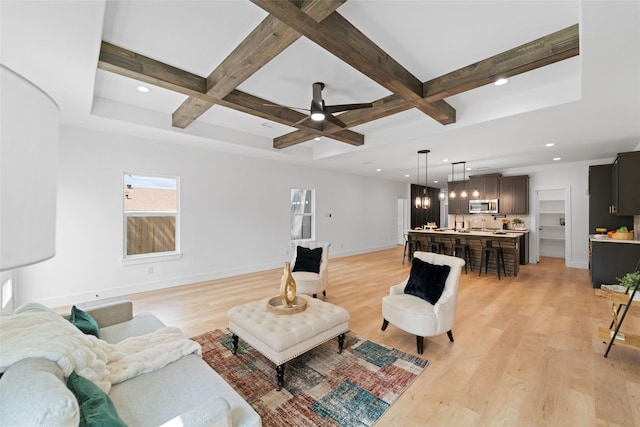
[[124, 174, 180, 259]]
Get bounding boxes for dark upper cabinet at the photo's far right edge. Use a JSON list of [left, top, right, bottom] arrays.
[[611, 151, 640, 215]]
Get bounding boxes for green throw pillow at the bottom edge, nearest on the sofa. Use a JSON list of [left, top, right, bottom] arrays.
[[67, 372, 127, 427]]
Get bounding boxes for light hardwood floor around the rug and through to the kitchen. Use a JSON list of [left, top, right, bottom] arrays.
[[122, 247, 640, 426]]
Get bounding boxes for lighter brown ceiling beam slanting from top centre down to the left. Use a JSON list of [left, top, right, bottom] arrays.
[[172, 0, 347, 128]]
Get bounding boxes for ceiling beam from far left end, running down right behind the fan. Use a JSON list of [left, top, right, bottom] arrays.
[[98, 42, 364, 145]]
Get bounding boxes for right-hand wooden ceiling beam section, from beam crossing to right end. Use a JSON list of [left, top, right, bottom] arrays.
[[423, 24, 580, 102]]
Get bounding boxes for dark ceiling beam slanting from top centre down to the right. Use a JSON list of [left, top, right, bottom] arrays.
[[251, 0, 455, 124]]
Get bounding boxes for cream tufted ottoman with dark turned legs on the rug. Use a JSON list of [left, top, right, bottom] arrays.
[[228, 295, 349, 390]]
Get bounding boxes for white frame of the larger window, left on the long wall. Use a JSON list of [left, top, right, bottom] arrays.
[[122, 172, 182, 265]]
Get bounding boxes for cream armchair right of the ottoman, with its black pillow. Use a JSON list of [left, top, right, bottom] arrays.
[[382, 252, 465, 354]]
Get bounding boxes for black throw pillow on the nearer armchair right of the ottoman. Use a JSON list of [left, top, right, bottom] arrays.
[[404, 258, 451, 305]]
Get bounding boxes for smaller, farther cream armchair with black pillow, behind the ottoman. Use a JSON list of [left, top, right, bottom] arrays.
[[291, 242, 331, 298]]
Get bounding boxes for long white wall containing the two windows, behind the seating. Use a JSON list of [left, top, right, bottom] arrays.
[[18, 127, 407, 306]]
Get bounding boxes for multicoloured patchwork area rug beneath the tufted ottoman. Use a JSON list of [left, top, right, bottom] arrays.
[[193, 329, 429, 427]]
